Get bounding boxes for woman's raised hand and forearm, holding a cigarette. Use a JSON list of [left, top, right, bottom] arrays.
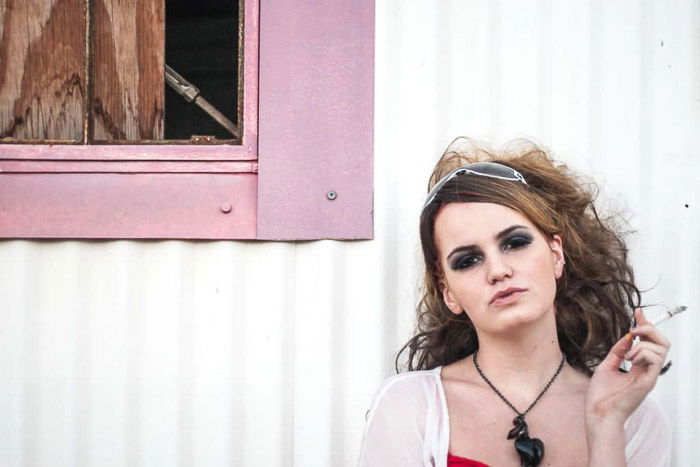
[[586, 308, 670, 466]]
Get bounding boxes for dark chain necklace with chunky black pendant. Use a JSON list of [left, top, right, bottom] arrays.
[[473, 352, 566, 467]]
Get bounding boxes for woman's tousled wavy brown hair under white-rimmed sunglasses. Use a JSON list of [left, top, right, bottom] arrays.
[[396, 138, 641, 375]]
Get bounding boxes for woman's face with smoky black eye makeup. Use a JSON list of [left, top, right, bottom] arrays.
[[434, 203, 564, 333]]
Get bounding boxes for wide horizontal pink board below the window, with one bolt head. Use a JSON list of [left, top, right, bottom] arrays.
[[0, 174, 257, 239]]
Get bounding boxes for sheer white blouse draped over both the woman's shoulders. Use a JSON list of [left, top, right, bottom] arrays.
[[358, 367, 671, 467]]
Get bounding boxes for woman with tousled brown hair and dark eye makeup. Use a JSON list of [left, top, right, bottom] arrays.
[[360, 142, 670, 467]]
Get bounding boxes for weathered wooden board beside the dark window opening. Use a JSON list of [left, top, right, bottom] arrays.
[[92, 0, 165, 141]]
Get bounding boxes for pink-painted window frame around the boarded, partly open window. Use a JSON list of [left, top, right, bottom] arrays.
[[0, 0, 374, 240]]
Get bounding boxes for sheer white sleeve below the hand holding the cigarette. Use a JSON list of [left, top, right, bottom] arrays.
[[625, 397, 671, 466]]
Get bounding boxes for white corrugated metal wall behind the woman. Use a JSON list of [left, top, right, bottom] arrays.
[[0, 0, 700, 467]]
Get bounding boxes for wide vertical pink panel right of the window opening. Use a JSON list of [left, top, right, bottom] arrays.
[[258, 0, 374, 240]]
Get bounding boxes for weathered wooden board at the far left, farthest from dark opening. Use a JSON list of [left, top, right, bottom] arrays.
[[0, 0, 85, 141]]
